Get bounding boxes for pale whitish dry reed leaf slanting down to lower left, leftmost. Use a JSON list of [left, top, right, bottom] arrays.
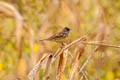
[[27, 54, 49, 80]]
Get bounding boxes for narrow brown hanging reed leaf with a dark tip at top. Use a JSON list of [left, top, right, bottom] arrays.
[[43, 54, 53, 80]]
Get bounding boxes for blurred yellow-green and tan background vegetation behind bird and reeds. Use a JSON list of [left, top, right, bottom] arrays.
[[0, 0, 120, 80]]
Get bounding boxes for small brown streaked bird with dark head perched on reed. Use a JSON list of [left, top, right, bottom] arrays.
[[39, 27, 70, 43]]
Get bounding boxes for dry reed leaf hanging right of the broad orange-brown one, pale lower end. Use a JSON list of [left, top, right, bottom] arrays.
[[69, 44, 85, 80]]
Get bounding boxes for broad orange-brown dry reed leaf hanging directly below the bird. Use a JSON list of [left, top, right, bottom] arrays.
[[56, 49, 68, 80]]
